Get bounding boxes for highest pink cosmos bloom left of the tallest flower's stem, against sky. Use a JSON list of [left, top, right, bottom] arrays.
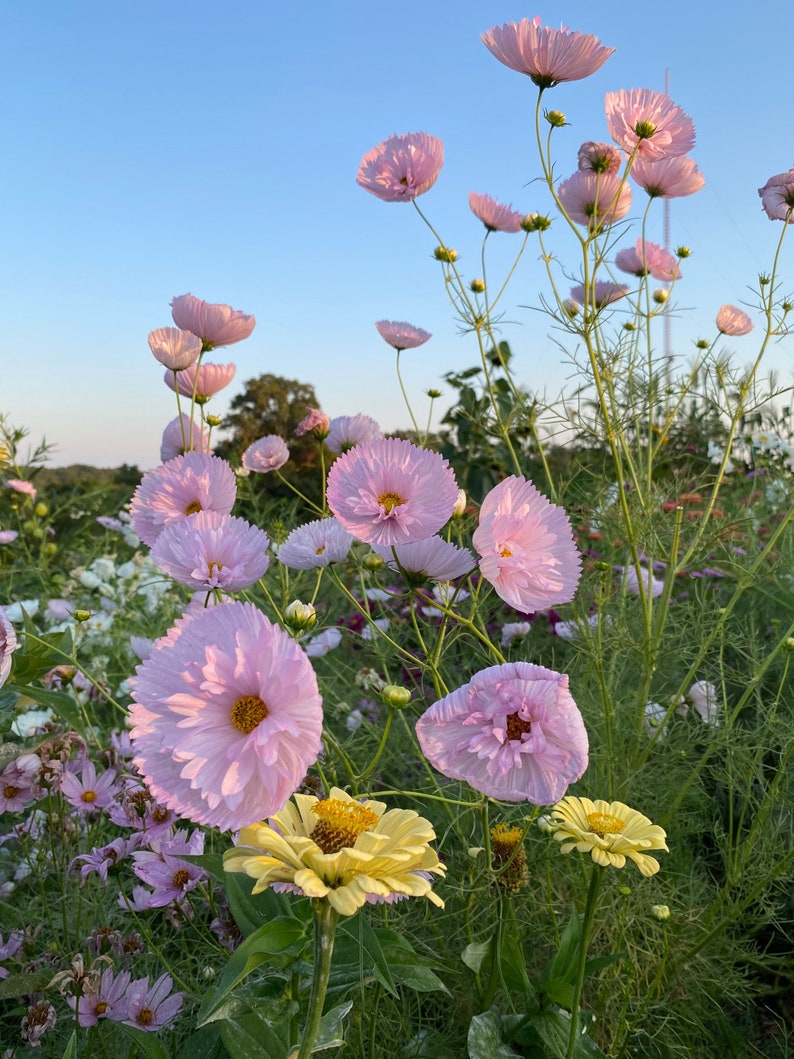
[[356, 132, 444, 202]]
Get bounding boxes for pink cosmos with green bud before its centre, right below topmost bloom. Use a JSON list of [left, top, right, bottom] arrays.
[[604, 88, 694, 161]]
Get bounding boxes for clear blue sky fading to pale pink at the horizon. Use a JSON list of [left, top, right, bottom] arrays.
[[0, 0, 794, 468]]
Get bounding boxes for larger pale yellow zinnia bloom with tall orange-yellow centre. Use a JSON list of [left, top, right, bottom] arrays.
[[223, 787, 446, 916]]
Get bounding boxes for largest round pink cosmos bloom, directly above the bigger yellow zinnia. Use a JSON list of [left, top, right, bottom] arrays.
[[130, 602, 323, 830]]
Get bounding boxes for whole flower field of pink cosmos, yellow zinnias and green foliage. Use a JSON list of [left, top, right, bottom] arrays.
[[0, 19, 794, 1059]]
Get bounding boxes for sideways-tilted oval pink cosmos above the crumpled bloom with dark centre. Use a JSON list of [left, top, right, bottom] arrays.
[[472, 474, 581, 614]]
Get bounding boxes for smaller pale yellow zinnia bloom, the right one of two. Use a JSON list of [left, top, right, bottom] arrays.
[[548, 797, 669, 876]]
